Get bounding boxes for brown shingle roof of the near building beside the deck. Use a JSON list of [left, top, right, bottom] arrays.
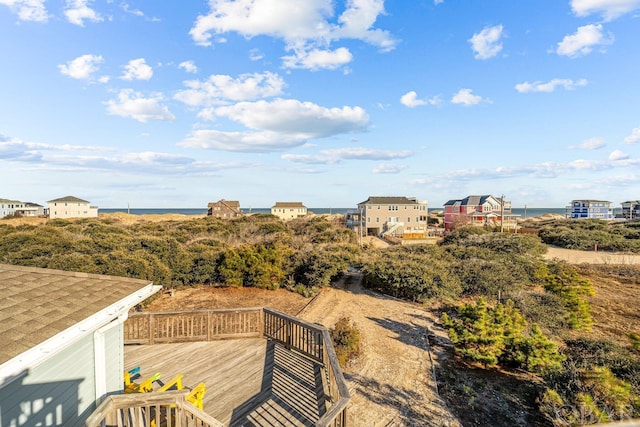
[[0, 264, 150, 364]]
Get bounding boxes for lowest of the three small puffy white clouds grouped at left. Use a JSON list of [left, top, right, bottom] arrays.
[[105, 89, 175, 123]]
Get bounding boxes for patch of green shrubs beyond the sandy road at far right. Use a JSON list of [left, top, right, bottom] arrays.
[[538, 219, 640, 252]]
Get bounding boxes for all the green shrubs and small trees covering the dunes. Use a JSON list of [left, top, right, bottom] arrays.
[[0, 215, 640, 425]]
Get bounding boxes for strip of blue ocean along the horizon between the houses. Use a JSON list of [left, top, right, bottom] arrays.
[[99, 207, 566, 218]]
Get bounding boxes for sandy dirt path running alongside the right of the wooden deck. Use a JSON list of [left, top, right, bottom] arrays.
[[299, 273, 460, 427]]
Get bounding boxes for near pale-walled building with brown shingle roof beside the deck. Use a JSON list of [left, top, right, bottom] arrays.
[[0, 264, 161, 427]]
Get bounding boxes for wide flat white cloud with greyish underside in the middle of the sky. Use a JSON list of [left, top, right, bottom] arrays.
[[179, 99, 369, 152]]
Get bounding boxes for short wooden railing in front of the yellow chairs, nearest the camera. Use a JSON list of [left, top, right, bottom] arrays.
[[85, 390, 224, 427]]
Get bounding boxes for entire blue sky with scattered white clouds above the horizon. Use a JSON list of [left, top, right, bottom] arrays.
[[0, 0, 640, 208]]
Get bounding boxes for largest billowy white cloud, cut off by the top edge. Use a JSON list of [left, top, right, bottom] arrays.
[[189, 0, 397, 69]]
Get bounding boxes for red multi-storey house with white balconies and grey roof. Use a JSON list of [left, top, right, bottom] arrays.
[[444, 195, 519, 231]]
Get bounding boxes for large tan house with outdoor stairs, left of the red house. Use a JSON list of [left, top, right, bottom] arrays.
[[358, 196, 428, 237]]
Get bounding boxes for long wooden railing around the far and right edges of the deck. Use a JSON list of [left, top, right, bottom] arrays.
[[113, 307, 350, 427]]
